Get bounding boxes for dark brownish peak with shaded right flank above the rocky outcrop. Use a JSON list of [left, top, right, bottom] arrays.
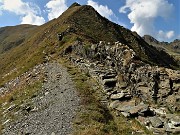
[[56, 3, 176, 66]]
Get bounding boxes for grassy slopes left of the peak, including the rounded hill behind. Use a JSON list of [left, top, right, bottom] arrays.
[[0, 3, 83, 85]]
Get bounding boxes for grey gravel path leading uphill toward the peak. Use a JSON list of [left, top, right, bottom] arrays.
[[3, 63, 80, 135]]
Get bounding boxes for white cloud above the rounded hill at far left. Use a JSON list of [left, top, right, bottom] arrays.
[[1, 0, 45, 25]]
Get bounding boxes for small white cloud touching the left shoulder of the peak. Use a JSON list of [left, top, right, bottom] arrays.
[[45, 0, 68, 20]]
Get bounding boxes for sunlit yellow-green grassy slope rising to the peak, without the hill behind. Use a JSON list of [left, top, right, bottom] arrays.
[[0, 5, 82, 85]]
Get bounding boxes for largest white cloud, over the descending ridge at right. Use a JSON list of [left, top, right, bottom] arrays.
[[119, 0, 174, 39]]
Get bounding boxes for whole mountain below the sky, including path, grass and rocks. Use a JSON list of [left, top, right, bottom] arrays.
[[0, 3, 180, 135]]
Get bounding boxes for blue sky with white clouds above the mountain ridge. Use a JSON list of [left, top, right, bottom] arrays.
[[0, 0, 180, 42]]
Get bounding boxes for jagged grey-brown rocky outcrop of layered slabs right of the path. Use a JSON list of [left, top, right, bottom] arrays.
[[65, 41, 180, 134]]
